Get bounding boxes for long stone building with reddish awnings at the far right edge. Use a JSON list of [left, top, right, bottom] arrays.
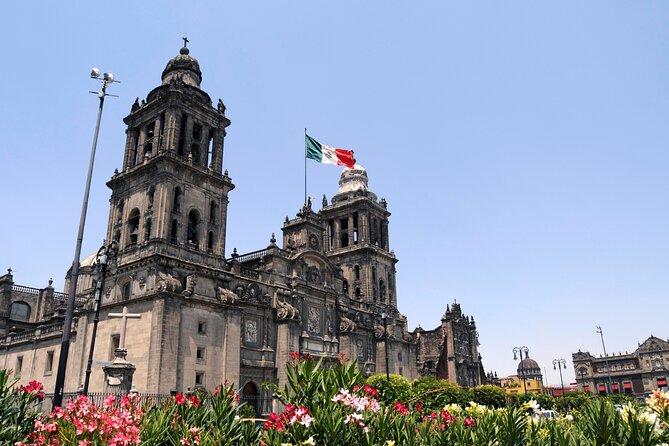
[[572, 335, 669, 399]]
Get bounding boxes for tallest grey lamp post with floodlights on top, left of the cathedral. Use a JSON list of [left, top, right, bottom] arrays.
[[53, 68, 118, 407]]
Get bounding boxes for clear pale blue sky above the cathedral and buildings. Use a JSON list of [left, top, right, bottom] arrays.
[[0, 1, 669, 383]]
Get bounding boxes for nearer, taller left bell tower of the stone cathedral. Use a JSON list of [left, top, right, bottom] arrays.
[[102, 39, 234, 266]]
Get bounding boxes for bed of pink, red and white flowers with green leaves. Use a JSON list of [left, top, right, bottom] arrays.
[[0, 355, 669, 446]]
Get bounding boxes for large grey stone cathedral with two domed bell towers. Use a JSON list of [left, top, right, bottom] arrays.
[[0, 46, 485, 413]]
